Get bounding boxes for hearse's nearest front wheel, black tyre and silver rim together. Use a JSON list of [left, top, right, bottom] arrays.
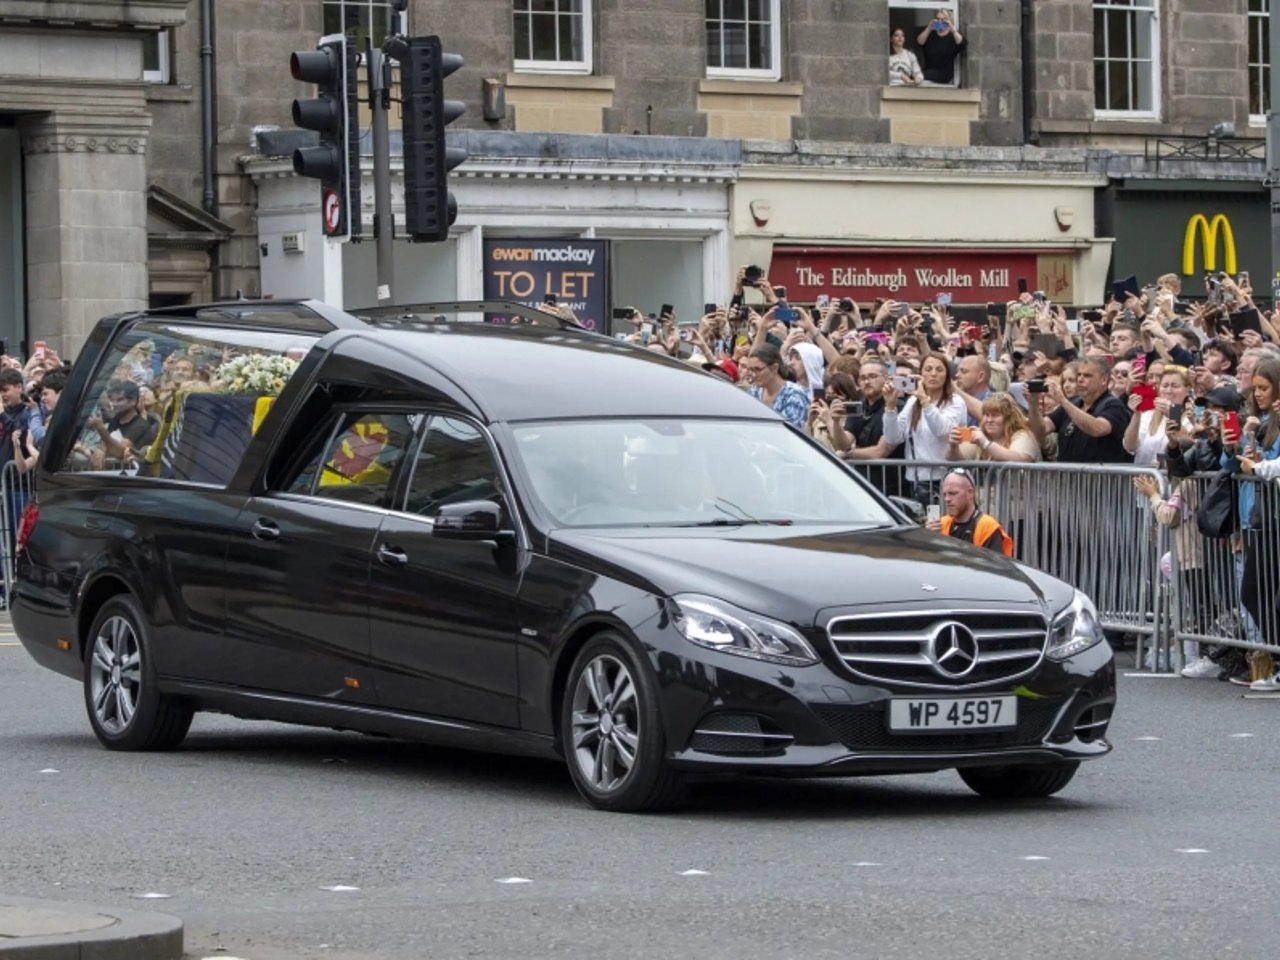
[[561, 631, 686, 813]]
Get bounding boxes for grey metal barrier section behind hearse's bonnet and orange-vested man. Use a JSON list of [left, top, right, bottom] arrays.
[[849, 461, 1172, 669]]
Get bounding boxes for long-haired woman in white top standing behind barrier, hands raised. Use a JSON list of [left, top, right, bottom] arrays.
[[884, 353, 969, 503]]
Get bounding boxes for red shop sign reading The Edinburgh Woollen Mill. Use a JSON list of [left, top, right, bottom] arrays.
[[769, 247, 1070, 303]]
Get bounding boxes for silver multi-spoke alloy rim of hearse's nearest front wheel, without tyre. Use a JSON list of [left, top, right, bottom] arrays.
[[572, 654, 640, 794]]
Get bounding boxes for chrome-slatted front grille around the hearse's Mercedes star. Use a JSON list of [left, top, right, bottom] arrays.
[[827, 609, 1050, 690]]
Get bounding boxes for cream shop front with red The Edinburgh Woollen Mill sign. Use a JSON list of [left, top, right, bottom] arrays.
[[732, 146, 1111, 306]]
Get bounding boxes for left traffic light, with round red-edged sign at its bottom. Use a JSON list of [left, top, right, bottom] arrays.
[[289, 35, 361, 239]]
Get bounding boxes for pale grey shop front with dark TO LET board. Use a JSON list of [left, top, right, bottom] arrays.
[[247, 131, 737, 332]]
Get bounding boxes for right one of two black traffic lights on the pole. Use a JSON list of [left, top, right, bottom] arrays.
[[390, 37, 467, 243]]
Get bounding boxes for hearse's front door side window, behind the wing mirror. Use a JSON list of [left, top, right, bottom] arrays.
[[406, 416, 502, 517]]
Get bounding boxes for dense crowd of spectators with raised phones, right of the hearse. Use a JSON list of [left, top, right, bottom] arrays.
[[614, 268, 1280, 690]]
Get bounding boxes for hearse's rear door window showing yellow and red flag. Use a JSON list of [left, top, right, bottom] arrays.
[[285, 413, 415, 507]]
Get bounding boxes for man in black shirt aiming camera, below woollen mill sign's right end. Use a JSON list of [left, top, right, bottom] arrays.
[[1028, 357, 1133, 463]]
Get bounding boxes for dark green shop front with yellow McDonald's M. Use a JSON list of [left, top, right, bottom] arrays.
[[1101, 179, 1272, 298]]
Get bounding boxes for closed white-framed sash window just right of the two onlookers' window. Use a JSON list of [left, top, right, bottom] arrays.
[[1093, 0, 1160, 119]]
